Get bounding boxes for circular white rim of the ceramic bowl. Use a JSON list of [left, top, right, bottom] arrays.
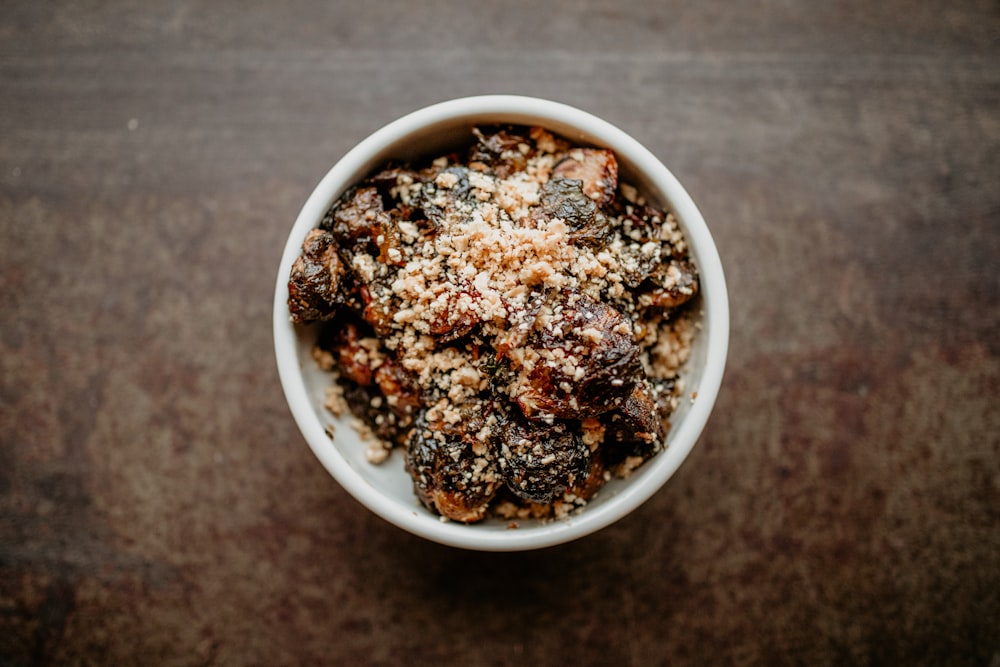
[[273, 95, 729, 551]]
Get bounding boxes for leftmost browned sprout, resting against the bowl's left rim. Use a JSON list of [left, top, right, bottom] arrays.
[[288, 229, 344, 324]]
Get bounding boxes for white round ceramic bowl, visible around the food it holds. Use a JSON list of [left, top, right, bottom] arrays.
[[274, 95, 729, 551]]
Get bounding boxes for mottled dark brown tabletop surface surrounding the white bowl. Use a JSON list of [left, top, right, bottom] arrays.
[[0, 0, 1000, 667]]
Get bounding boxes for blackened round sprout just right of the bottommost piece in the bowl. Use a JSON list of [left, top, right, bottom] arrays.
[[494, 410, 593, 504]]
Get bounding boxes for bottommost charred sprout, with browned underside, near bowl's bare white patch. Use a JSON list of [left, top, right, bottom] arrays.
[[406, 413, 502, 523]]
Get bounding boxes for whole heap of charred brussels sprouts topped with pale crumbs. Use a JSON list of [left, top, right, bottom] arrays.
[[288, 126, 699, 523]]
